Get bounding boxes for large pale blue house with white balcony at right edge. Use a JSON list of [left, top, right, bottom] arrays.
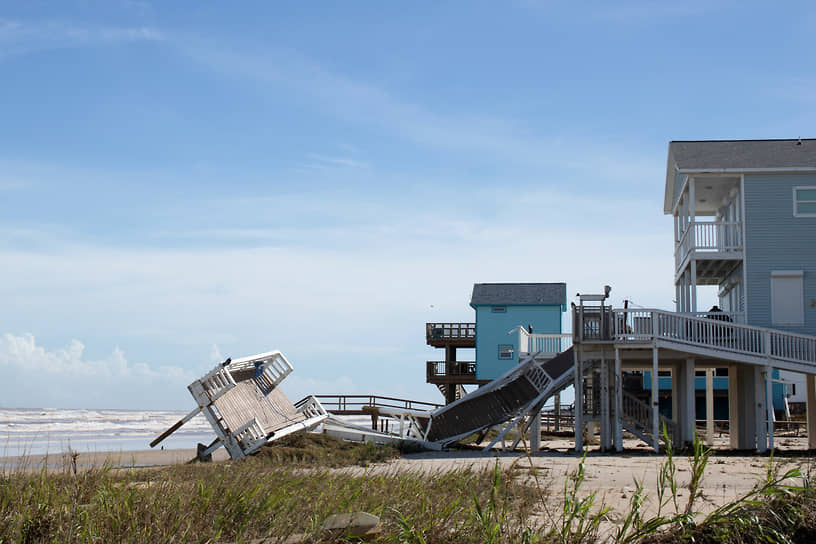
[[663, 140, 816, 412]]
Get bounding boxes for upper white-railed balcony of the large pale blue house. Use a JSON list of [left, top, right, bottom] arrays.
[[674, 220, 744, 285]]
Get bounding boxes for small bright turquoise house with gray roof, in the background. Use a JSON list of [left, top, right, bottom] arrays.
[[470, 283, 567, 380]]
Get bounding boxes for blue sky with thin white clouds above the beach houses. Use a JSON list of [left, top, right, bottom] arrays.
[[0, 0, 816, 409]]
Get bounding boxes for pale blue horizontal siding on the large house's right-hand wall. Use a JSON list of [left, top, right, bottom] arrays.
[[745, 174, 816, 335]]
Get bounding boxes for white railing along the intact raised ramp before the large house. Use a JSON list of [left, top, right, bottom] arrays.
[[613, 309, 816, 365]]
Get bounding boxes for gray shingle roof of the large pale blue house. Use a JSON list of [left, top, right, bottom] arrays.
[[669, 140, 816, 171]]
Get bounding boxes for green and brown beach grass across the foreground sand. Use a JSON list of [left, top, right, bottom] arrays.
[[0, 435, 816, 544]]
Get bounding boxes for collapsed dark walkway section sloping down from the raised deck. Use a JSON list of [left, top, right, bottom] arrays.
[[424, 348, 574, 449]]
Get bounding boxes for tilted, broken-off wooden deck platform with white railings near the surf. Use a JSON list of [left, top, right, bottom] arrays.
[[150, 351, 328, 459]]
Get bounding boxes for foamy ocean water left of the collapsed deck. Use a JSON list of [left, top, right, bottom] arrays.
[[0, 408, 215, 457]]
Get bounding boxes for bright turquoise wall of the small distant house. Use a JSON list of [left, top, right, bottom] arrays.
[[476, 305, 564, 380]]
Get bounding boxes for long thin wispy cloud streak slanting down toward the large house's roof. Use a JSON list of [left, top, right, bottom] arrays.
[[170, 36, 659, 185]]
